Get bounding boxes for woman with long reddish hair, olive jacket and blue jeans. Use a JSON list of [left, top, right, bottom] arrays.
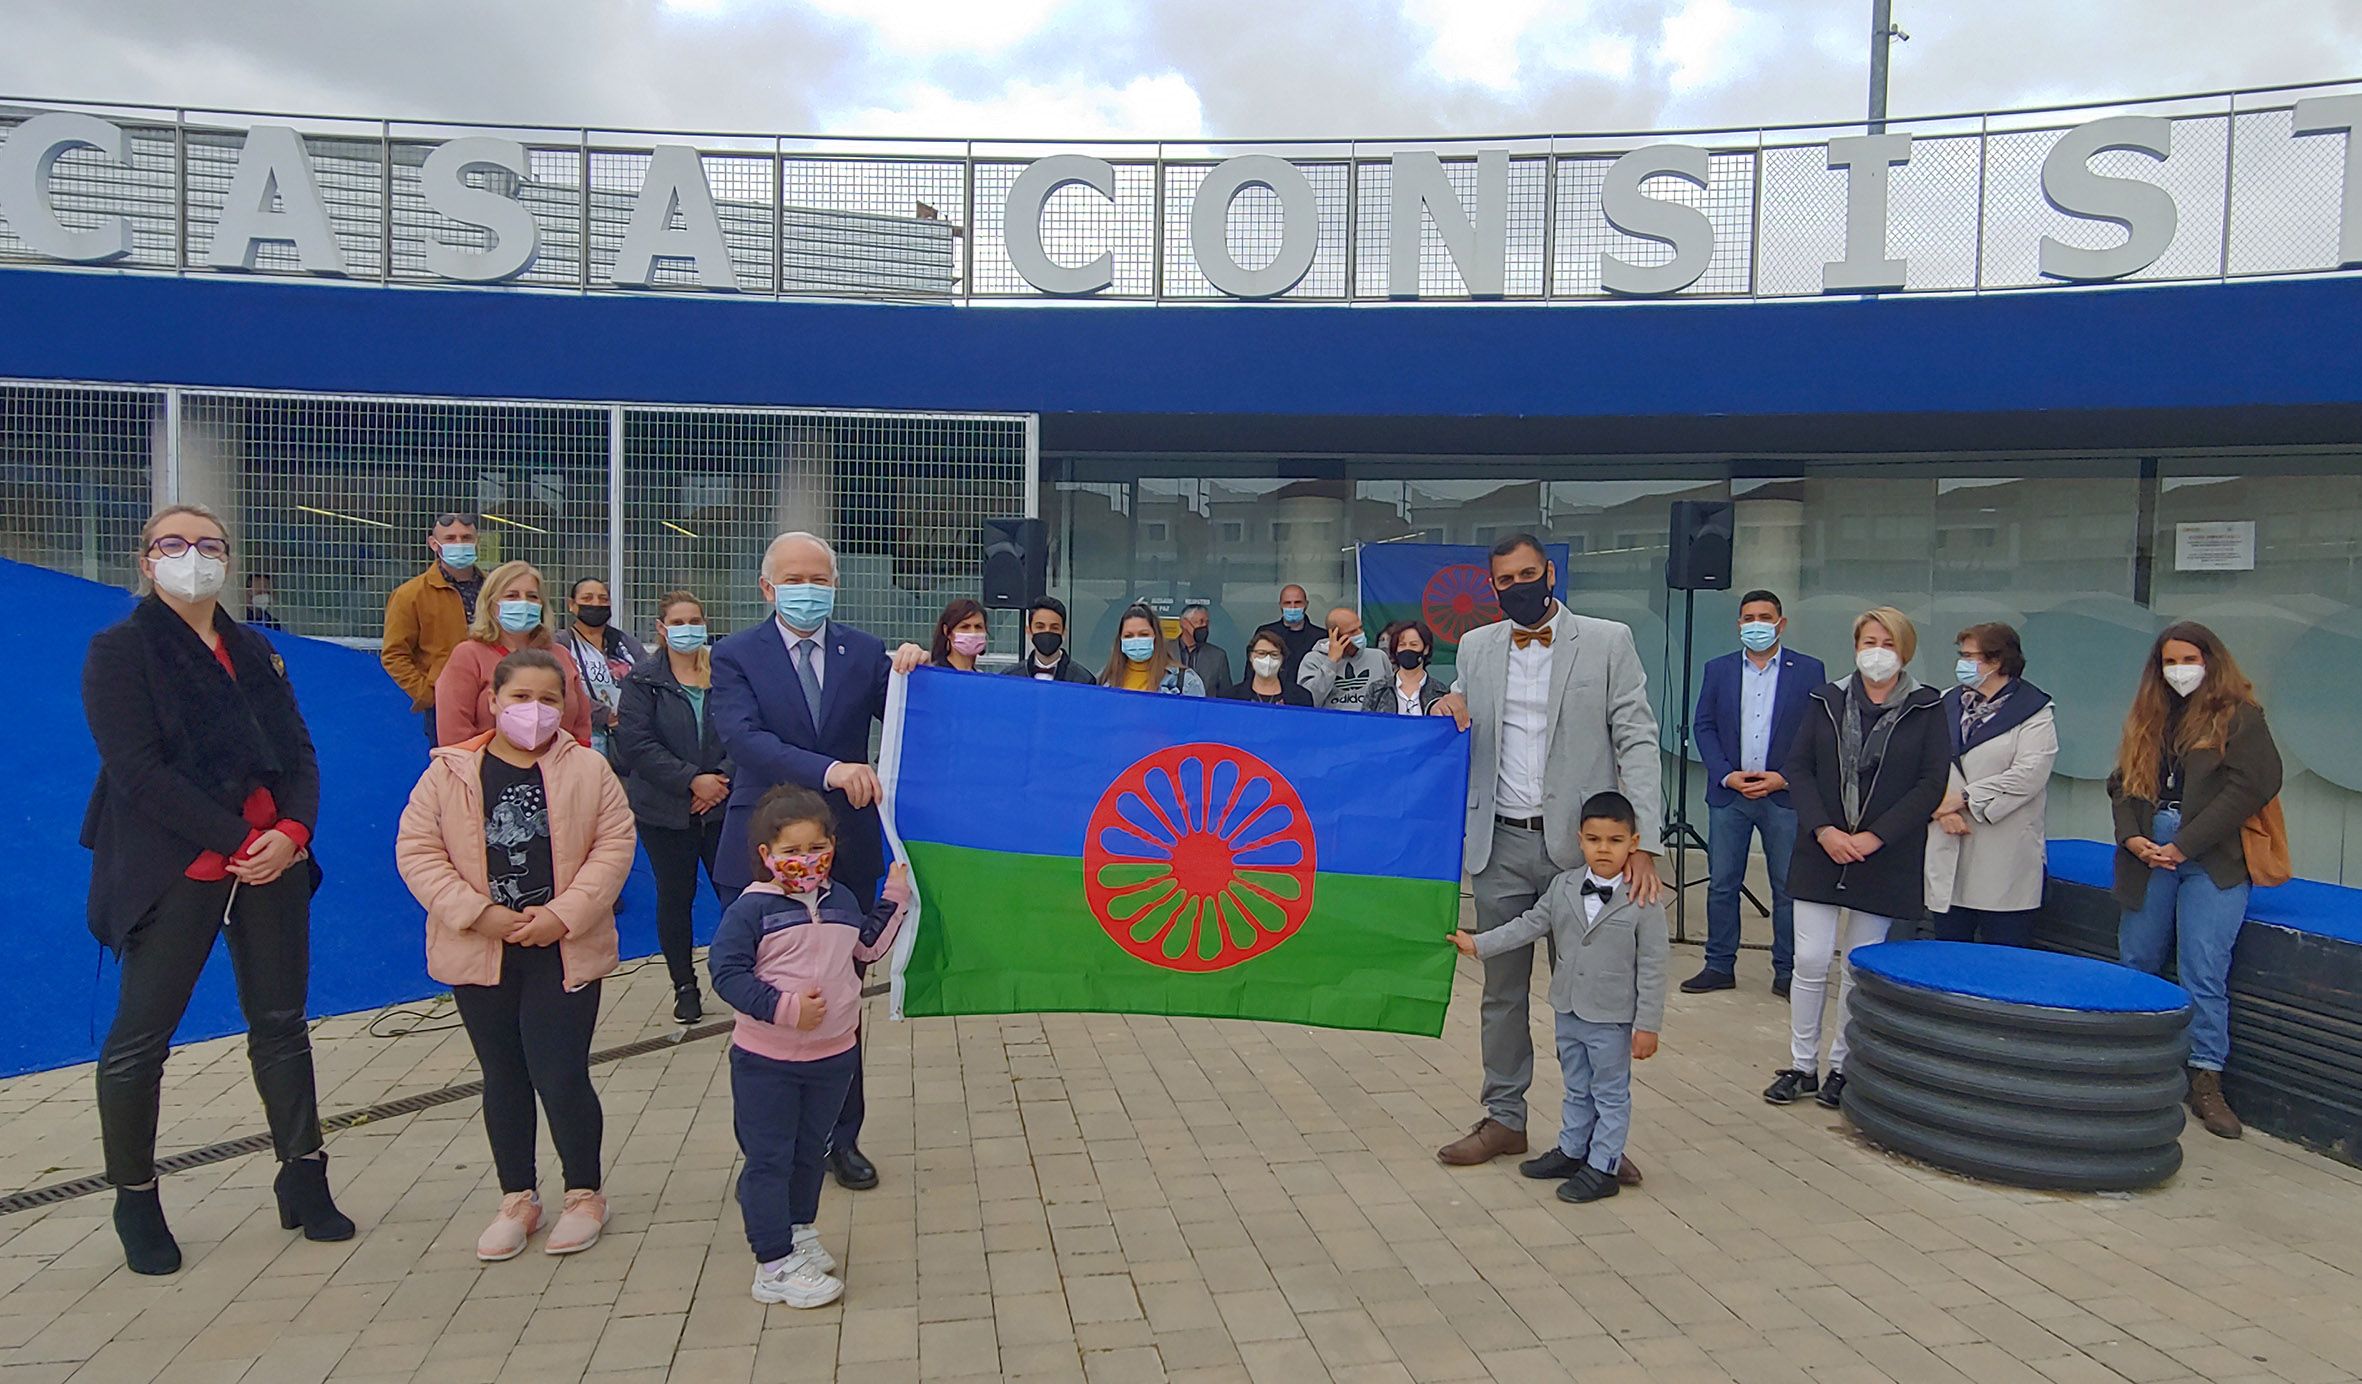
[[2107, 621, 2282, 1138]]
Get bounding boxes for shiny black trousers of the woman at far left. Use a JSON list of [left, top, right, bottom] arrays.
[[99, 864, 319, 1188]]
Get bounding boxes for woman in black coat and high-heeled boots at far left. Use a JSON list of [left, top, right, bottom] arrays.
[[83, 505, 352, 1273]]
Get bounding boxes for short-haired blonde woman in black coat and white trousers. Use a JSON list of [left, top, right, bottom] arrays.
[[1764, 605, 1951, 1110]]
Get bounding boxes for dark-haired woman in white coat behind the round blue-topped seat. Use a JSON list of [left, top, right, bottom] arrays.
[[1927, 624, 2060, 947]]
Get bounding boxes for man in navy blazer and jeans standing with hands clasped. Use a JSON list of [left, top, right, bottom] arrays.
[[1682, 590, 1828, 994]]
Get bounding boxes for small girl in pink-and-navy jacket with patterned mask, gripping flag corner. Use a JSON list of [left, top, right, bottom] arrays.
[[706, 784, 909, 1306]]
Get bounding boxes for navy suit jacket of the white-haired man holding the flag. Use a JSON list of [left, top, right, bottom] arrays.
[[711, 619, 890, 892]]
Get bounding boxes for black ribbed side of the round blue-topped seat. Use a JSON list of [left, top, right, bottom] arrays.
[[1845, 942, 2190, 1190]]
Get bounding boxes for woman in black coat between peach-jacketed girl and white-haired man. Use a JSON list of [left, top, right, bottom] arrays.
[[614, 590, 730, 1023]]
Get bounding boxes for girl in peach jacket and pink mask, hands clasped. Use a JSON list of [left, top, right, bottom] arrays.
[[394, 649, 638, 1261]]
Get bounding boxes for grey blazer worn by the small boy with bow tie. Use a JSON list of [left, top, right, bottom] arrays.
[[1476, 869, 1668, 1032]]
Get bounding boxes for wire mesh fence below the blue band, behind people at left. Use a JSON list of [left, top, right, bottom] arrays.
[[0, 380, 1035, 645]]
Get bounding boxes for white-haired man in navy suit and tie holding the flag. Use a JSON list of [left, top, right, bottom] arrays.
[[711, 534, 924, 1190]]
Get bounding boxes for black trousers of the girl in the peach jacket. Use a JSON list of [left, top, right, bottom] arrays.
[[451, 945, 607, 1193]]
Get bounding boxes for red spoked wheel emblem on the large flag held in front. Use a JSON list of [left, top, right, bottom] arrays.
[[1082, 744, 1313, 971]]
